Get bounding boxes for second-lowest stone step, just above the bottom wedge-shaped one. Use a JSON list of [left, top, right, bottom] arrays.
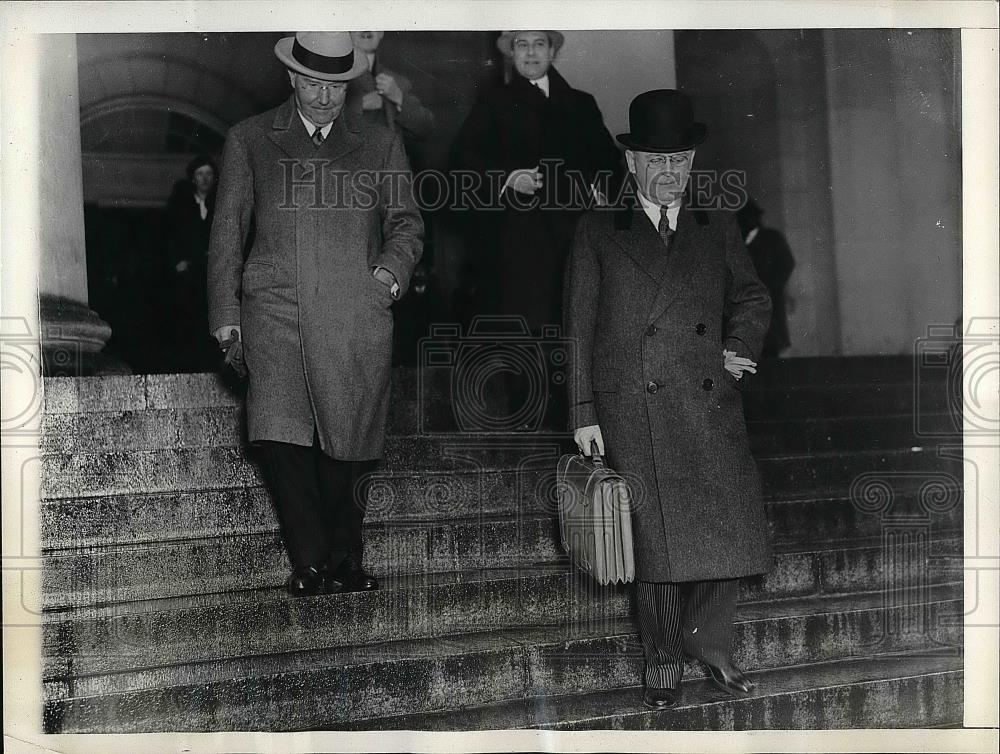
[[45, 586, 961, 732]]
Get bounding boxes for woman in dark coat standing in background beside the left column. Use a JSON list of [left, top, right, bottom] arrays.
[[166, 155, 219, 372]]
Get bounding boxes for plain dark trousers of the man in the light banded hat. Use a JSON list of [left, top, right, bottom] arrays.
[[259, 441, 378, 568]]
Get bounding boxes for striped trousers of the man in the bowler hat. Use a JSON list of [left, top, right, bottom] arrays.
[[635, 579, 740, 689]]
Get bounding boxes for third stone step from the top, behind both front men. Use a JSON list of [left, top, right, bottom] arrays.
[[41, 438, 962, 500]]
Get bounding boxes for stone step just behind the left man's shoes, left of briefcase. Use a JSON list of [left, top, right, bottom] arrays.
[[42, 515, 564, 608]]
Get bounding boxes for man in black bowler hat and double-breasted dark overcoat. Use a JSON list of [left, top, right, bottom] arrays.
[[565, 89, 771, 709]]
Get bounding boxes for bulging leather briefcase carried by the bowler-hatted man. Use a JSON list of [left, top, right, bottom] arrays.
[[556, 448, 635, 585]]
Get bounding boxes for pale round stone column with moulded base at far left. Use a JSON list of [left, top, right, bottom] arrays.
[[35, 34, 111, 376]]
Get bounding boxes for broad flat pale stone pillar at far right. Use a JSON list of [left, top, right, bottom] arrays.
[[823, 29, 962, 356]]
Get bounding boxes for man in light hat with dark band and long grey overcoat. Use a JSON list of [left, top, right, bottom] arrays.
[[209, 32, 423, 596]]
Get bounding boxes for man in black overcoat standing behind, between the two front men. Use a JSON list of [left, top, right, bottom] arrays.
[[454, 31, 621, 427]]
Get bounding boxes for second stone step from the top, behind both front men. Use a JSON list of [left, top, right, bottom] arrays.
[[40, 396, 960, 457]]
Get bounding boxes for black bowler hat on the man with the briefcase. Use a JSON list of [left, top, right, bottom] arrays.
[[617, 89, 708, 153]]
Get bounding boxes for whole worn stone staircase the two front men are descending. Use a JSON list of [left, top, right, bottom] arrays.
[[40, 358, 963, 733]]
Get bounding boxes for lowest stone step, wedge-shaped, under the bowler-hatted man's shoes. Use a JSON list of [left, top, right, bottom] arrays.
[[346, 650, 964, 731]]
